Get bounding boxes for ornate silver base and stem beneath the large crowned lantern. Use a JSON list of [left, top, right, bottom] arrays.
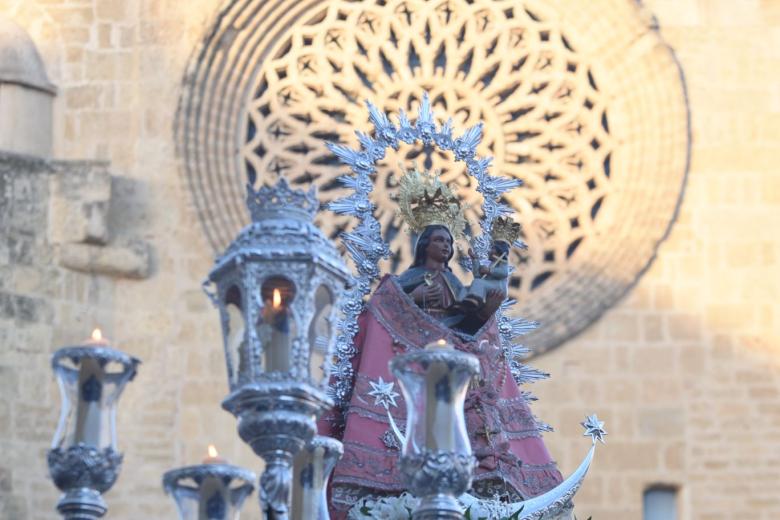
[[222, 382, 331, 520]]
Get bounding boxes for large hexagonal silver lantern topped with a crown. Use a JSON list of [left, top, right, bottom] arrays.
[[204, 179, 351, 518]]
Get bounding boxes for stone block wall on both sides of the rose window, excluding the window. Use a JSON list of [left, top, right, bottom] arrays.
[[0, 0, 780, 520]]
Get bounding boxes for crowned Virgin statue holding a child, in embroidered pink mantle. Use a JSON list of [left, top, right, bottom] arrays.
[[319, 171, 562, 519]]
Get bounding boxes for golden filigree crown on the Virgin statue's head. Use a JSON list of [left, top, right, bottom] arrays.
[[395, 169, 466, 240]]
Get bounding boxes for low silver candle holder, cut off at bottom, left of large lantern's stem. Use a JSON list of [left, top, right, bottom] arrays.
[[163, 446, 257, 520]]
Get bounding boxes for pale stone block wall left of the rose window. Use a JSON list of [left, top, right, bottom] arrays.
[[0, 0, 266, 520]]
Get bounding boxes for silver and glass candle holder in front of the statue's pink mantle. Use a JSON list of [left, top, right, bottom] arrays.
[[390, 340, 479, 520]]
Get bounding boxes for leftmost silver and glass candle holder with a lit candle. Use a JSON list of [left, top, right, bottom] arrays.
[[48, 329, 140, 520]]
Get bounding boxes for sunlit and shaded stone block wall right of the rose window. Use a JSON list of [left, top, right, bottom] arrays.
[[535, 0, 780, 520]]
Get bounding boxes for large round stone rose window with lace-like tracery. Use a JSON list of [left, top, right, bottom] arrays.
[[177, 0, 688, 351]]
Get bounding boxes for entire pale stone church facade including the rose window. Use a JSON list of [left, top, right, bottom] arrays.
[[0, 0, 780, 520]]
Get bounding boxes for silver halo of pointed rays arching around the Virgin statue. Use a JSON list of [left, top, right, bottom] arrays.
[[327, 92, 550, 431]]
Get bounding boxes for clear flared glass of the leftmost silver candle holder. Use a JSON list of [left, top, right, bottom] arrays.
[[52, 357, 129, 450]]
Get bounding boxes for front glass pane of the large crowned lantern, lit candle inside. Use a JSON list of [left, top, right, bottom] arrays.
[[257, 276, 296, 372]]
